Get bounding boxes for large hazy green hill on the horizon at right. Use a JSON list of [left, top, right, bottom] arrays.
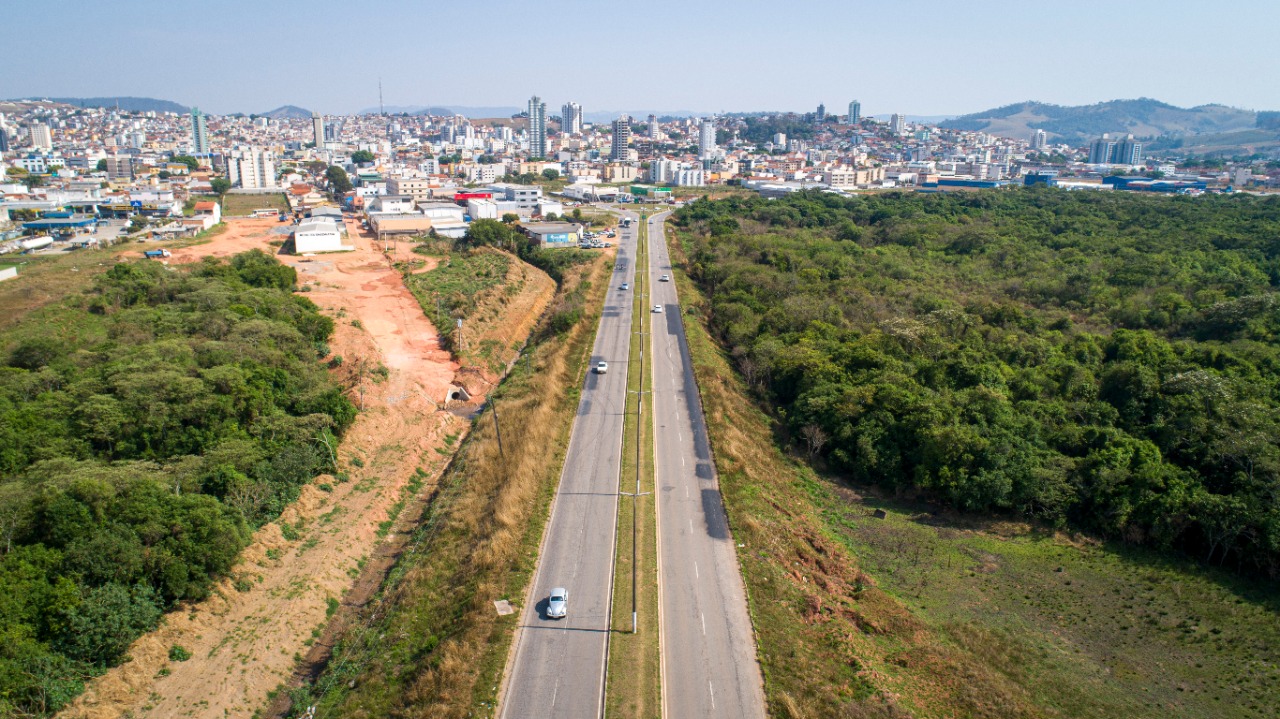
[[941, 97, 1257, 145]]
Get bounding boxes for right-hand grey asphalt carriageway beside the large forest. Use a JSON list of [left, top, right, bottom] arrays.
[[649, 212, 764, 719]]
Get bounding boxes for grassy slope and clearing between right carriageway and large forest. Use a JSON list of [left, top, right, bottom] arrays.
[[672, 221, 1280, 719]]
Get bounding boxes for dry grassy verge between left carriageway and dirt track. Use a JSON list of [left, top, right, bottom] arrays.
[[279, 256, 608, 718]]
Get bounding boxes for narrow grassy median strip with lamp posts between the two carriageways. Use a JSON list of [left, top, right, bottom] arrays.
[[604, 212, 662, 718]]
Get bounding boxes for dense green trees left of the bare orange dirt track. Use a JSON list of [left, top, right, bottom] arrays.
[[0, 251, 355, 716]]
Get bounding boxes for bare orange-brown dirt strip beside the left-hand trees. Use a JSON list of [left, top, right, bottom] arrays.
[[64, 214, 554, 719]]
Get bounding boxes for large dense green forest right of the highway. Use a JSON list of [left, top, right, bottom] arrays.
[[676, 188, 1280, 577]]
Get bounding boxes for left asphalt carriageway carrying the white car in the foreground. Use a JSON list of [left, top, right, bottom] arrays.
[[502, 212, 639, 719]]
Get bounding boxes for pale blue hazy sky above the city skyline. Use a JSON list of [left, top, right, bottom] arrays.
[[0, 0, 1280, 115]]
